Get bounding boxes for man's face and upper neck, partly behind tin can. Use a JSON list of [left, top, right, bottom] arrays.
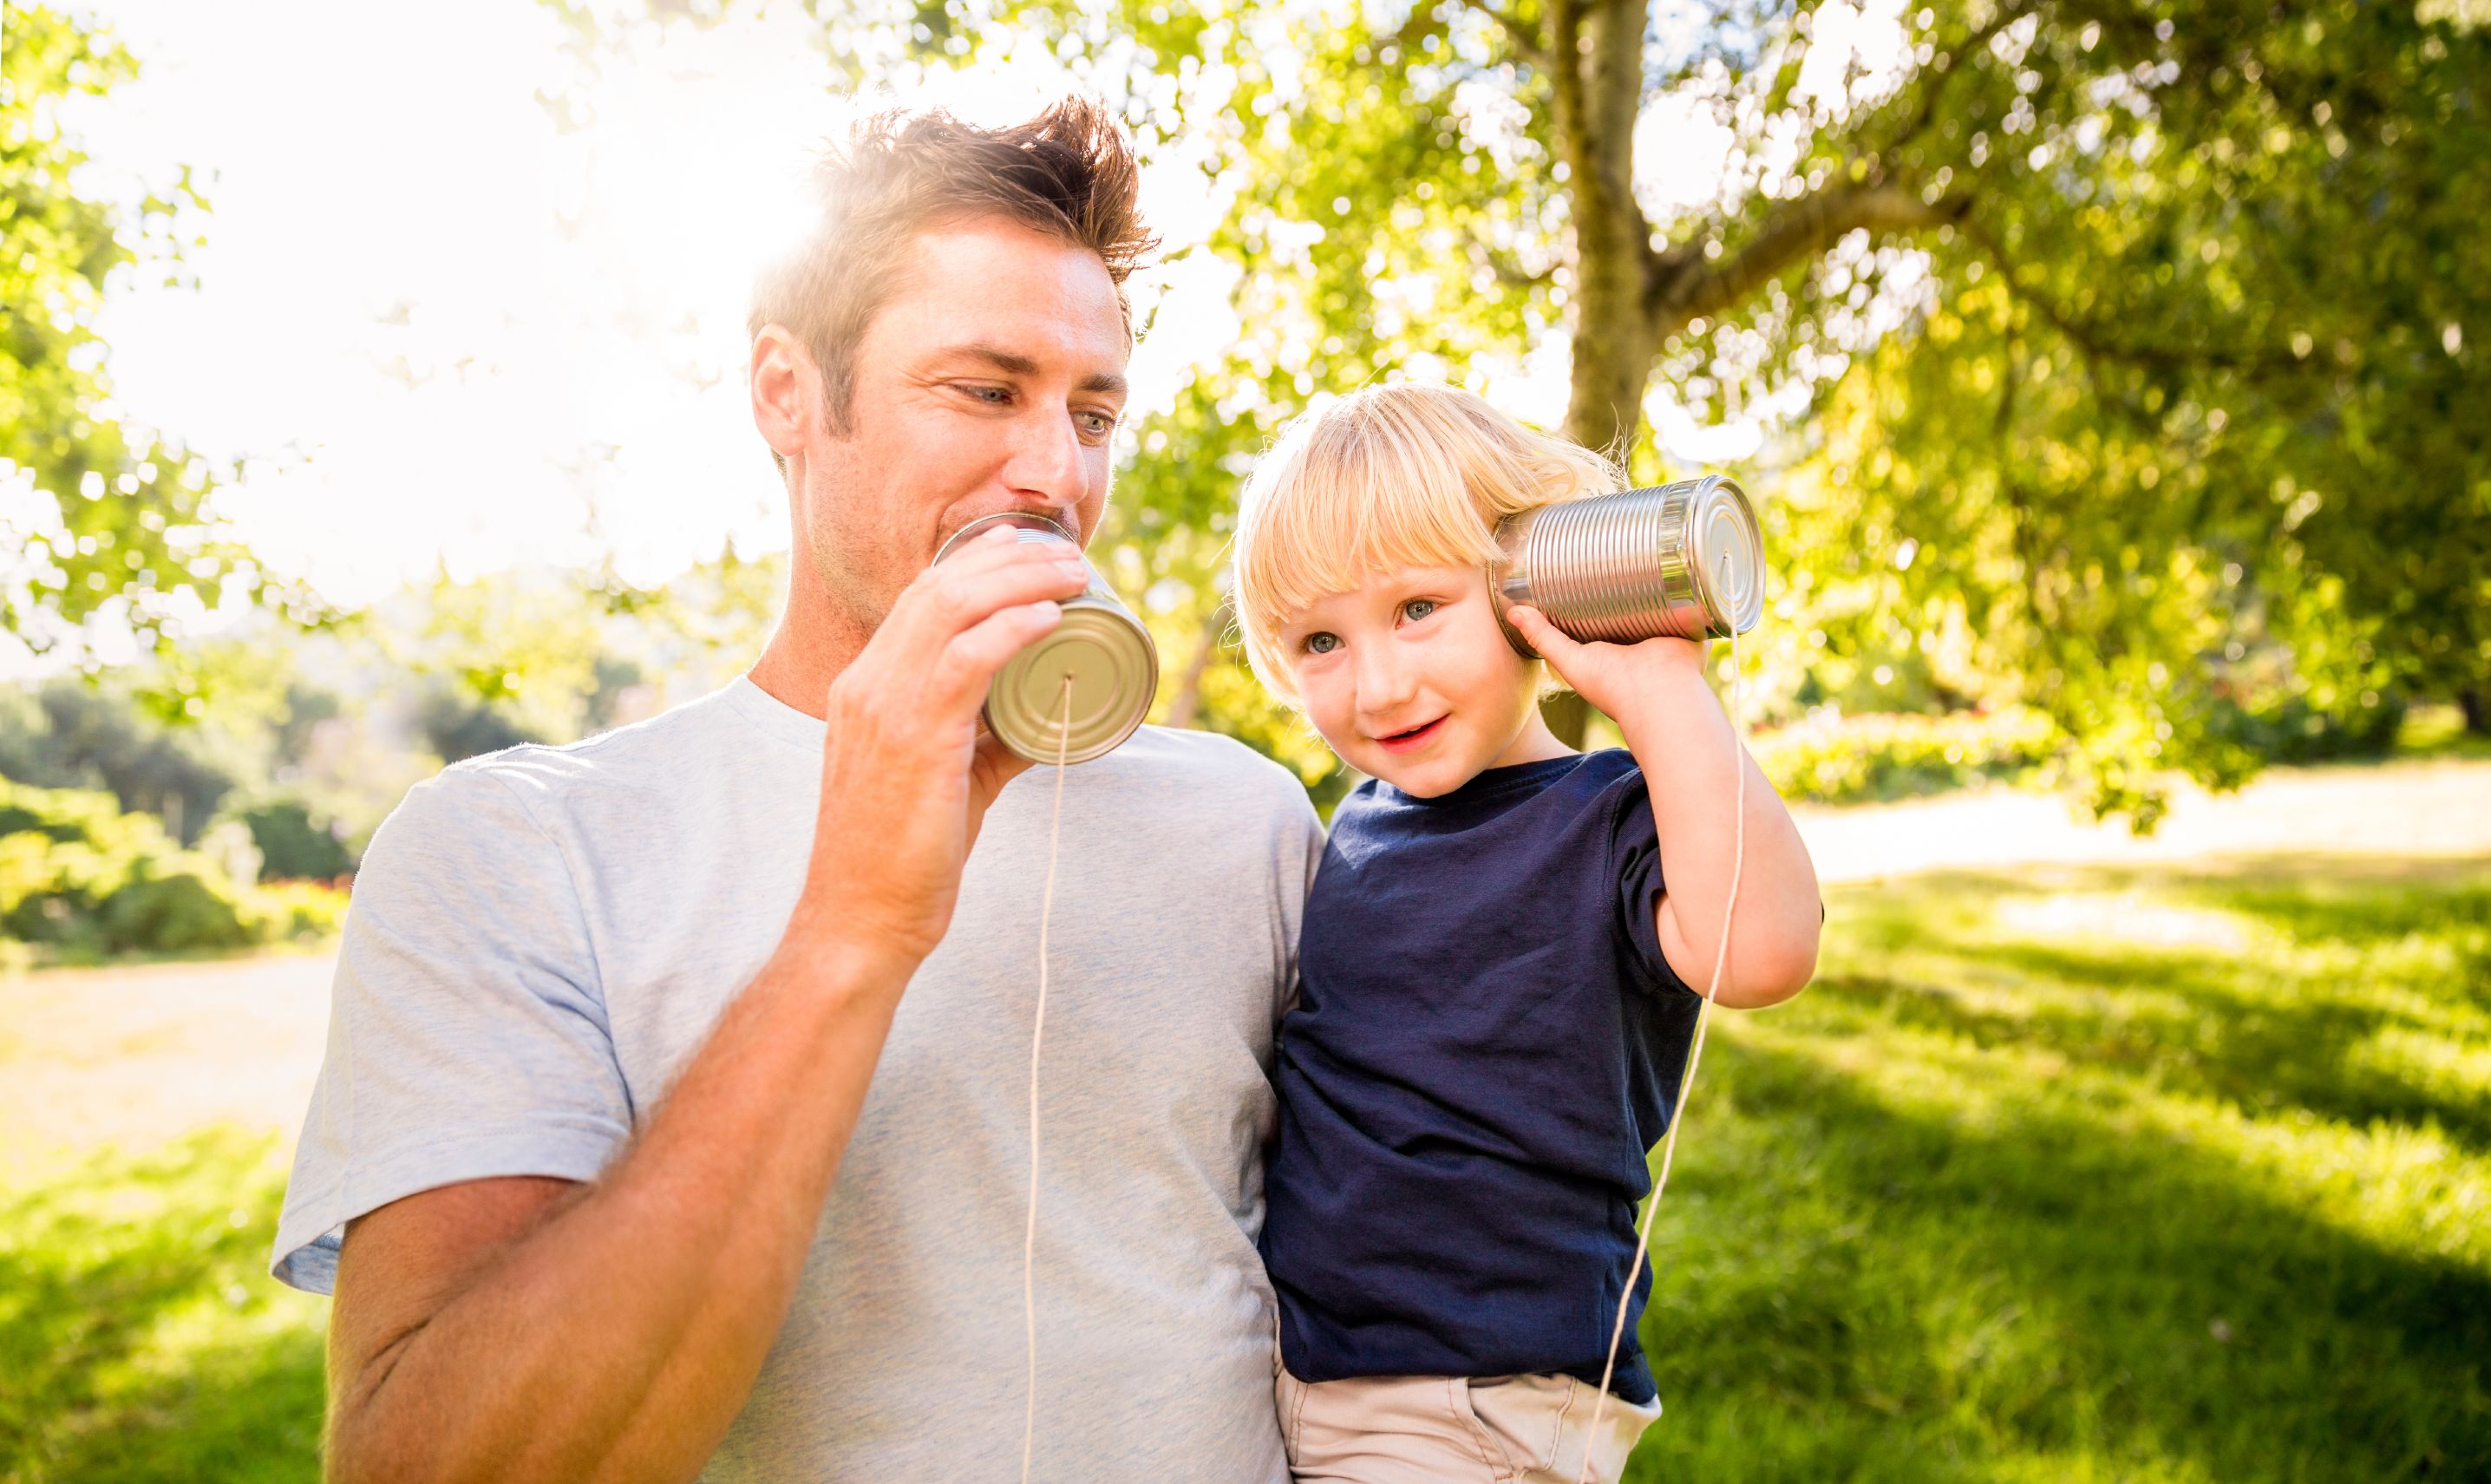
[[800, 217, 1131, 627]]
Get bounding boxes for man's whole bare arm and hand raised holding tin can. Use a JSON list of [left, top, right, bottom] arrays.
[[329, 530, 1081, 1484]]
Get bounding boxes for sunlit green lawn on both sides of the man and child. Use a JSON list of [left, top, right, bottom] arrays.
[[0, 864, 2491, 1484]]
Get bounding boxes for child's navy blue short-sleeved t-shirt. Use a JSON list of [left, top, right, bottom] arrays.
[[1263, 749, 1702, 1402]]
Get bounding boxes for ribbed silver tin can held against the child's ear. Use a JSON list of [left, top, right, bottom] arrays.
[[1492, 473, 1763, 657]]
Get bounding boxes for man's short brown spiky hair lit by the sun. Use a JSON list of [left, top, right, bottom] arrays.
[[748, 97, 1158, 434]]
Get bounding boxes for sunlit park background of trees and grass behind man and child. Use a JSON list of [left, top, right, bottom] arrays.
[[0, 0, 2491, 1484]]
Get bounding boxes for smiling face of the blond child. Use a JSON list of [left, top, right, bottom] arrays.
[[1280, 568, 1540, 800]]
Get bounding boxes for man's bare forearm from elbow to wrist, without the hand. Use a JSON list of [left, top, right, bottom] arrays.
[[329, 944, 914, 1484]]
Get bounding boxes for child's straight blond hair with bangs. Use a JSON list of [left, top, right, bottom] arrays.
[[1236, 383, 1625, 704]]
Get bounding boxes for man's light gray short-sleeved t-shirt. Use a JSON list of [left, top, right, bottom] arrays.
[[271, 680, 1320, 1484]]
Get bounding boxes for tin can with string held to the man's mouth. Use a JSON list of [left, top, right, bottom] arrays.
[[934, 511, 1158, 762]]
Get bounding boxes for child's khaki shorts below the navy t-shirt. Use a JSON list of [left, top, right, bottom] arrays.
[[1273, 1367, 1662, 1484]]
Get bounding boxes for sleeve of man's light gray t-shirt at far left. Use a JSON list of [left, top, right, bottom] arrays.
[[269, 767, 632, 1292]]
